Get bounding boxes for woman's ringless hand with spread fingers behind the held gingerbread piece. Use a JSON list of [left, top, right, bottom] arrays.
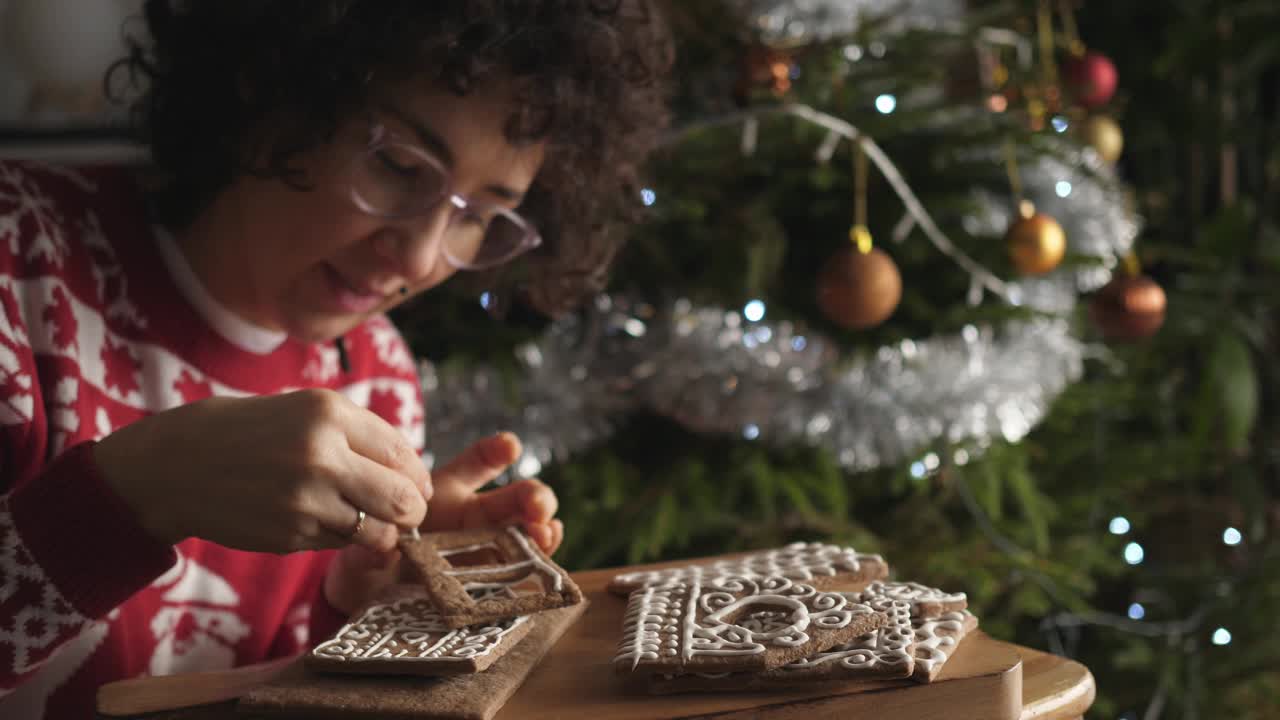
[[324, 433, 564, 614]]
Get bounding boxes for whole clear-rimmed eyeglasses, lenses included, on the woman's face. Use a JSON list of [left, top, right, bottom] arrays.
[[351, 123, 543, 270]]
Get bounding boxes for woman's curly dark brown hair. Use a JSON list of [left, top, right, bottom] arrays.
[[119, 0, 672, 314]]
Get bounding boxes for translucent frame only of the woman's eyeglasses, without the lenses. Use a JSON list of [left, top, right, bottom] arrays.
[[348, 119, 543, 272]]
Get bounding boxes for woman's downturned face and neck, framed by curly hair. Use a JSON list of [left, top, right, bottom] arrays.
[[182, 79, 545, 342]]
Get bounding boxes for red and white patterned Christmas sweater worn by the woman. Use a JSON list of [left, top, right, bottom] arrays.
[[0, 163, 422, 720]]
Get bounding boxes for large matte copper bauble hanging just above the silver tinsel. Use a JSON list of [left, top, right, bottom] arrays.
[[818, 245, 902, 331]]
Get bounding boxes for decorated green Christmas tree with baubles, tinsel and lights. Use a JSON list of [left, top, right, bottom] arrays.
[[397, 0, 1280, 719]]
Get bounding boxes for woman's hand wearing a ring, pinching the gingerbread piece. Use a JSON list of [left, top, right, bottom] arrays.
[[95, 389, 433, 553]]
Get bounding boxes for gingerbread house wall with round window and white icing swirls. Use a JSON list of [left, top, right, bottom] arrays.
[[613, 578, 888, 673]]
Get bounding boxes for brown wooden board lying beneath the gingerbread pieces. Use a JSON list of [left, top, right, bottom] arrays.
[[99, 568, 1094, 720]]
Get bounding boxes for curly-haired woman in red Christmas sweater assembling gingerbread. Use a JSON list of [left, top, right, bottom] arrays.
[[0, 0, 667, 717]]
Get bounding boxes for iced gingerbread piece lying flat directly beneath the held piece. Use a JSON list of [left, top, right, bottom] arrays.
[[307, 585, 531, 675]]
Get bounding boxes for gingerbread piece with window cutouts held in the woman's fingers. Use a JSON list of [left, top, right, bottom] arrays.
[[399, 527, 582, 628]]
